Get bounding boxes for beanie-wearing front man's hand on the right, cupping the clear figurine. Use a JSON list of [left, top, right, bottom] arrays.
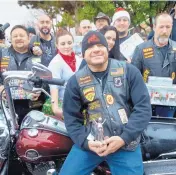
[[99, 136, 125, 156]]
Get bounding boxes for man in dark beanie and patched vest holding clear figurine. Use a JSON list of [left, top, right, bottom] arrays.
[[59, 31, 151, 175]]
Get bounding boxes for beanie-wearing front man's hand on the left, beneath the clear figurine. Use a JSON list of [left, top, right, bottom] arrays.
[[88, 140, 107, 156]]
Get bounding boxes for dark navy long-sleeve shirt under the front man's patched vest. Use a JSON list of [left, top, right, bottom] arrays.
[[63, 60, 152, 149]]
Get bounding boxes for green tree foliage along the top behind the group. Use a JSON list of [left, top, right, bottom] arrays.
[[18, 0, 174, 26]]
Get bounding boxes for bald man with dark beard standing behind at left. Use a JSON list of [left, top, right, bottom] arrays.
[[30, 14, 57, 66]]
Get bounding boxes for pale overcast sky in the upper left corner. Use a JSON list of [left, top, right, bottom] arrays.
[[0, 0, 33, 36]]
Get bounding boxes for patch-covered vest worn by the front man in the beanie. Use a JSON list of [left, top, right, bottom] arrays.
[[75, 59, 140, 150]]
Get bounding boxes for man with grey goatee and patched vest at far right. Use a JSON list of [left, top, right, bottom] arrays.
[[132, 13, 176, 116]]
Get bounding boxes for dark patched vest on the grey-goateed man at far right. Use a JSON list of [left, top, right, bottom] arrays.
[[139, 39, 176, 84]]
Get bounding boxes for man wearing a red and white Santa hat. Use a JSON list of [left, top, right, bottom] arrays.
[[112, 7, 131, 60]]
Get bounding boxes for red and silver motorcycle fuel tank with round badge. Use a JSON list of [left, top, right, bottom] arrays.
[[16, 111, 73, 163]]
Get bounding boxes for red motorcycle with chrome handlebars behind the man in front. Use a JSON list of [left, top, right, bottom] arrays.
[[0, 64, 176, 175]]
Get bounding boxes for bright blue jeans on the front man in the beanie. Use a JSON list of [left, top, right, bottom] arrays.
[[59, 145, 143, 175]]
